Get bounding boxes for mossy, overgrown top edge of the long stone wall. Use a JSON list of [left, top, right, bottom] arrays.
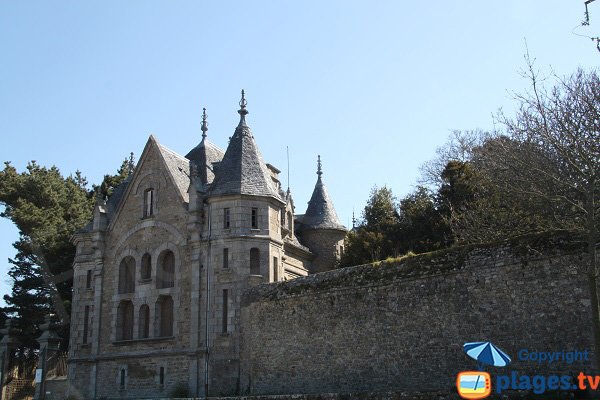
[[242, 231, 585, 306]]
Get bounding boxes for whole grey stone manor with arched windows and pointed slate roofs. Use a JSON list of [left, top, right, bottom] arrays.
[[69, 92, 346, 398]]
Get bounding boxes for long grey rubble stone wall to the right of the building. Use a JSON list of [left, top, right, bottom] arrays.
[[240, 233, 593, 395]]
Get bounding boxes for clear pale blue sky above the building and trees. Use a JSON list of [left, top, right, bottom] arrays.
[[0, 0, 600, 304]]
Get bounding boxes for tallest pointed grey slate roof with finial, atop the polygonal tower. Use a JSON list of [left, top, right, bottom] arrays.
[[211, 91, 283, 202]]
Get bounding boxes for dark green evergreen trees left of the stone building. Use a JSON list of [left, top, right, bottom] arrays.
[[0, 159, 131, 351]]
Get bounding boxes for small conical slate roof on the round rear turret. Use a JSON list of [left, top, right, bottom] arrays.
[[298, 156, 347, 231]]
